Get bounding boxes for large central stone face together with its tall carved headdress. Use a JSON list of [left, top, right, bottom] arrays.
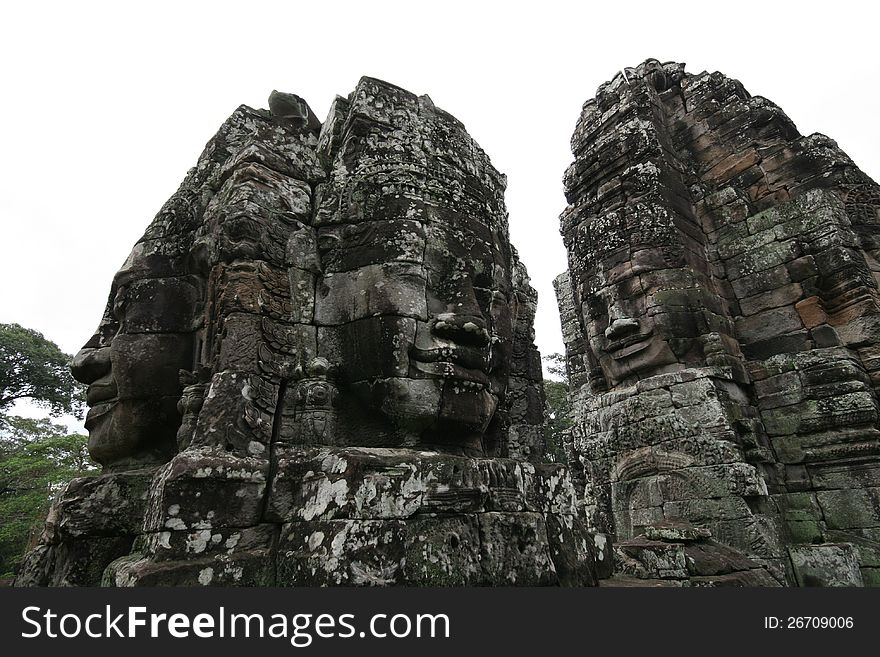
[[313, 83, 516, 453]]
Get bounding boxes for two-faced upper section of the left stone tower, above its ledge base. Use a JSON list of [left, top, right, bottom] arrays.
[[74, 81, 532, 467]]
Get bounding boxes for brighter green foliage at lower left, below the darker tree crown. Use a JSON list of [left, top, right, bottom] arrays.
[[0, 416, 97, 577]]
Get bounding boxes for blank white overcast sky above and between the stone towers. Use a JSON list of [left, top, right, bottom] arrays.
[[0, 0, 880, 428]]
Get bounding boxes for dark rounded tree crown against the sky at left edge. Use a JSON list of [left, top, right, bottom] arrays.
[[0, 324, 83, 417]]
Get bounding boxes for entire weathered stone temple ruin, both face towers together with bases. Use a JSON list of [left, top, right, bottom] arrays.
[[17, 60, 880, 586]]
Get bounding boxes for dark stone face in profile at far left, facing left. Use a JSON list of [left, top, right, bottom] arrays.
[[71, 240, 201, 469]]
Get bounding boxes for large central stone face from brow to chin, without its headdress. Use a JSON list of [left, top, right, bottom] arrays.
[[316, 200, 513, 452]]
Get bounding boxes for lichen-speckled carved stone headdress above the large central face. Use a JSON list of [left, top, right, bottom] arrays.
[[319, 78, 506, 227]]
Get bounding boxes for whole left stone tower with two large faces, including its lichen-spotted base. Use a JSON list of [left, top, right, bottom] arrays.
[[18, 78, 595, 586]]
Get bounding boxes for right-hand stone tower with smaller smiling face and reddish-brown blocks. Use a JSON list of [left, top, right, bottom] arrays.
[[556, 60, 880, 585]]
